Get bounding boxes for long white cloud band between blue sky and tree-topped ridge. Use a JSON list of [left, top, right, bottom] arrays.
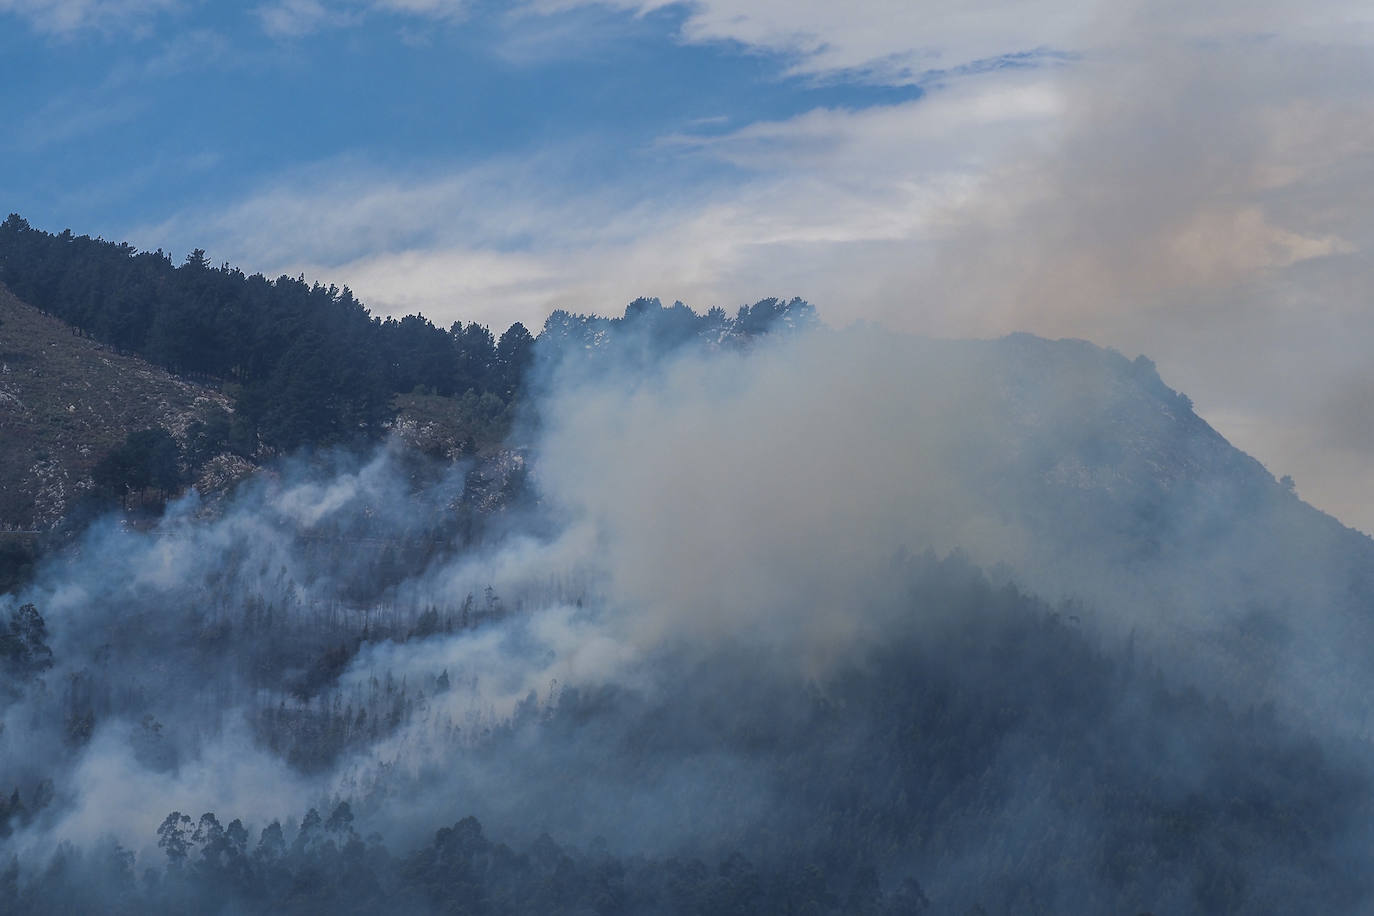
[[131, 73, 1058, 324]]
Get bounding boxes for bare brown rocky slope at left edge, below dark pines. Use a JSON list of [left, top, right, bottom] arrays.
[[0, 287, 232, 530]]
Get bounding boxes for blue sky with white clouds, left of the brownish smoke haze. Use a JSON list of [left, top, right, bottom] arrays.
[[0, 0, 1073, 324]]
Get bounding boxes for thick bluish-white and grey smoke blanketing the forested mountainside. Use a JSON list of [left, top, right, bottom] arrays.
[[0, 318, 1374, 912]]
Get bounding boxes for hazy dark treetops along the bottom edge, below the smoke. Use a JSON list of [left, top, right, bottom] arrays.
[[0, 802, 934, 916]]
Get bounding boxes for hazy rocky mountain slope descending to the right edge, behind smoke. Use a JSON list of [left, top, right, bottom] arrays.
[[951, 335, 1374, 733]]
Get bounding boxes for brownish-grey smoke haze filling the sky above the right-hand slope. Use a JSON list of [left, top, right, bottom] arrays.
[[857, 3, 1374, 530]]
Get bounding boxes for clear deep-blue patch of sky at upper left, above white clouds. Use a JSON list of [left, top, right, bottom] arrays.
[[0, 4, 921, 254]]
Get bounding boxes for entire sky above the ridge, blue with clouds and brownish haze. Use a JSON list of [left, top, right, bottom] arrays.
[[8, 0, 1374, 531]]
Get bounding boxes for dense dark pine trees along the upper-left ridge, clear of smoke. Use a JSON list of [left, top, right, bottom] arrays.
[[0, 214, 532, 458]]
